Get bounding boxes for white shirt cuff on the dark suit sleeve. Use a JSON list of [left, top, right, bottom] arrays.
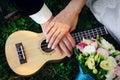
[[29, 4, 52, 24]]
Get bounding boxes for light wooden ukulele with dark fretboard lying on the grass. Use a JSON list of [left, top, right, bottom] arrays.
[[5, 27, 108, 76]]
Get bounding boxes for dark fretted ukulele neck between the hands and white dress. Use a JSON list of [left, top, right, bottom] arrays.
[[71, 27, 108, 43]]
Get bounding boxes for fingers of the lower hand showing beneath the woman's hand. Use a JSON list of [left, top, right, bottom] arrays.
[[55, 33, 75, 57]]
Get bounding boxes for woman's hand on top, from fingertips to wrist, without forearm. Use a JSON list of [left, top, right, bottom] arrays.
[[46, 10, 78, 49]]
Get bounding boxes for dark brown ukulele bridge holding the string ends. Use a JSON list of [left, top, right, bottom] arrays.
[[15, 43, 27, 64]]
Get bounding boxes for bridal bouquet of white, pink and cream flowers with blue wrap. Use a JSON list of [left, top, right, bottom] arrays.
[[75, 37, 120, 80]]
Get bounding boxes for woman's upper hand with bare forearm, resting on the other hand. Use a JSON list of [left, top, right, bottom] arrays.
[[45, 0, 86, 49]]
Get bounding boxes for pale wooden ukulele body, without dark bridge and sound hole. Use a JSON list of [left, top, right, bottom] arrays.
[[5, 31, 65, 76]]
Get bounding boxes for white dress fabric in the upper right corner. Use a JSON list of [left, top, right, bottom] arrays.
[[87, 0, 120, 44]]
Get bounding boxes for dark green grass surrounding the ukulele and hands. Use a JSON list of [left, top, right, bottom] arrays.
[[0, 0, 119, 80]]
